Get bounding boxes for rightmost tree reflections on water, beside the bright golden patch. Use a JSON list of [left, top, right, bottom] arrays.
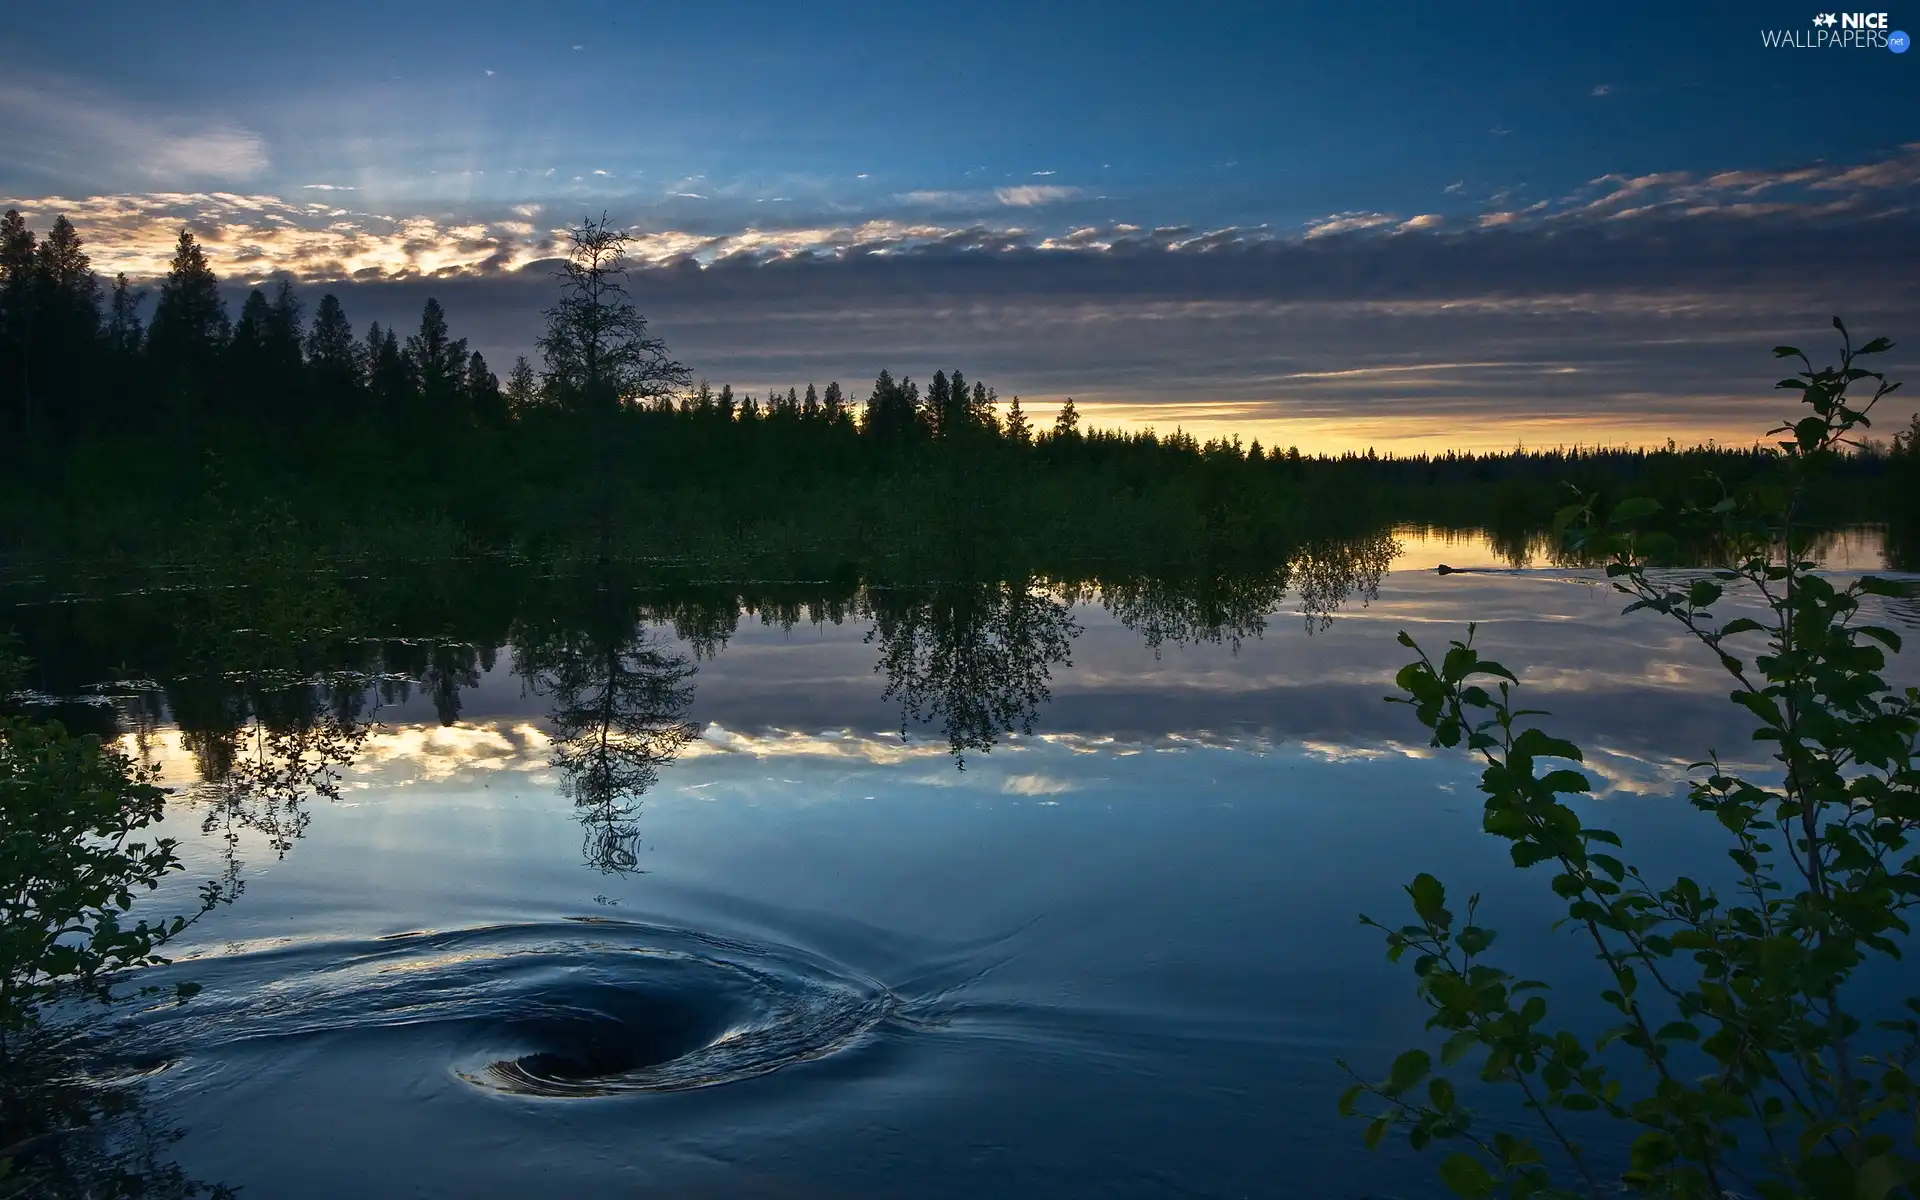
[[1100, 534, 1400, 659]]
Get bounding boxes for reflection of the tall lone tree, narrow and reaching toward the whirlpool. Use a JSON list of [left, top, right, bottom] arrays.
[[515, 584, 699, 872]]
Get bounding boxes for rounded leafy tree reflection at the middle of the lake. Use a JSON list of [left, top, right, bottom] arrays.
[[868, 578, 1079, 770]]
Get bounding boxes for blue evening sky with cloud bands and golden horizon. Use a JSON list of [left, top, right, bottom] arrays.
[[0, 0, 1920, 449]]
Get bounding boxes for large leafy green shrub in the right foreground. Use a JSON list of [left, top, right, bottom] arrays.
[[1340, 321, 1920, 1200]]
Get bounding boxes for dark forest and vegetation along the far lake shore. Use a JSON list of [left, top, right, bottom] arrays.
[[0, 213, 1920, 578]]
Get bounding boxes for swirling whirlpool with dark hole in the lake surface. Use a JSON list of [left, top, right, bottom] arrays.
[[135, 920, 899, 1096]]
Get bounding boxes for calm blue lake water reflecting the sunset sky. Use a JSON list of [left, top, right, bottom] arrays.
[[10, 532, 1920, 1198]]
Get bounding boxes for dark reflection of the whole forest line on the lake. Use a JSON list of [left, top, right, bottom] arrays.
[[13, 536, 1428, 870]]
